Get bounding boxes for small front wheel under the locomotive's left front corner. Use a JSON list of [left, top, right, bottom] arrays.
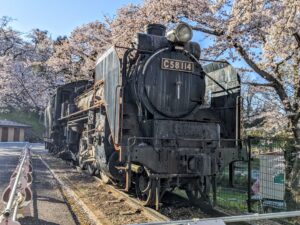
[[135, 170, 156, 206]]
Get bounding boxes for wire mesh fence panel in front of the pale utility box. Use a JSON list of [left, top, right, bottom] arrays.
[[249, 139, 300, 213]]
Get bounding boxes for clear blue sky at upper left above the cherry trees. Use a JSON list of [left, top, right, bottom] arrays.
[[0, 0, 142, 38]]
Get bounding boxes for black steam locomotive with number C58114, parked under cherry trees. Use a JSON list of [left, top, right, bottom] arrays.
[[45, 23, 244, 209]]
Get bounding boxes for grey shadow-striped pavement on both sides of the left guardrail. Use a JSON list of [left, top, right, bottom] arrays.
[[0, 143, 80, 225]]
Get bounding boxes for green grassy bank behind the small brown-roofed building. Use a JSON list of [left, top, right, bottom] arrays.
[[0, 111, 44, 139]]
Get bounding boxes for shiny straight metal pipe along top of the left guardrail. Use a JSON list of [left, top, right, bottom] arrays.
[[3, 144, 28, 217]]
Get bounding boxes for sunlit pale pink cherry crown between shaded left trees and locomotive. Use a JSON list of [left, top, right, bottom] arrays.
[[48, 21, 111, 81]]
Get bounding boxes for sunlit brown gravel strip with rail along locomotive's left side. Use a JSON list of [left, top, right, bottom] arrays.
[[40, 154, 169, 225]]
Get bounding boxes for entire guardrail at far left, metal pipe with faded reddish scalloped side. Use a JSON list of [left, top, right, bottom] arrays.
[[0, 144, 32, 225]]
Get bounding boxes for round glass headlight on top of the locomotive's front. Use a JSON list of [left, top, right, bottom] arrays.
[[167, 23, 193, 43]]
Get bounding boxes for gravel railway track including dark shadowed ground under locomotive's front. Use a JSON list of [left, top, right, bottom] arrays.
[[40, 150, 231, 225]]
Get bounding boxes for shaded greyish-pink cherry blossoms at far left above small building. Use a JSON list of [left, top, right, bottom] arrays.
[[0, 19, 62, 112]]
